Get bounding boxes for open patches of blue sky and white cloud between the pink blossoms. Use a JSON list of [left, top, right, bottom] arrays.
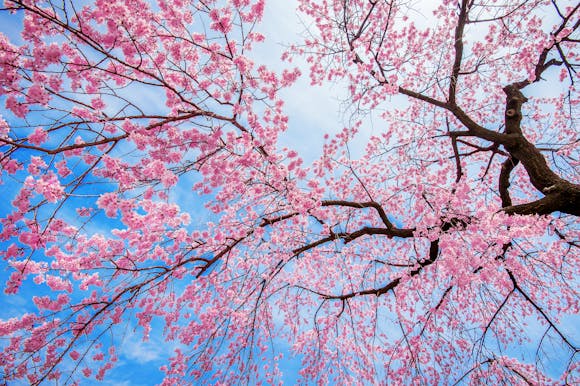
[[0, 0, 577, 386]]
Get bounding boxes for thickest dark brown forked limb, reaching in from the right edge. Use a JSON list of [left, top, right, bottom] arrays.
[[336, 0, 580, 217]]
